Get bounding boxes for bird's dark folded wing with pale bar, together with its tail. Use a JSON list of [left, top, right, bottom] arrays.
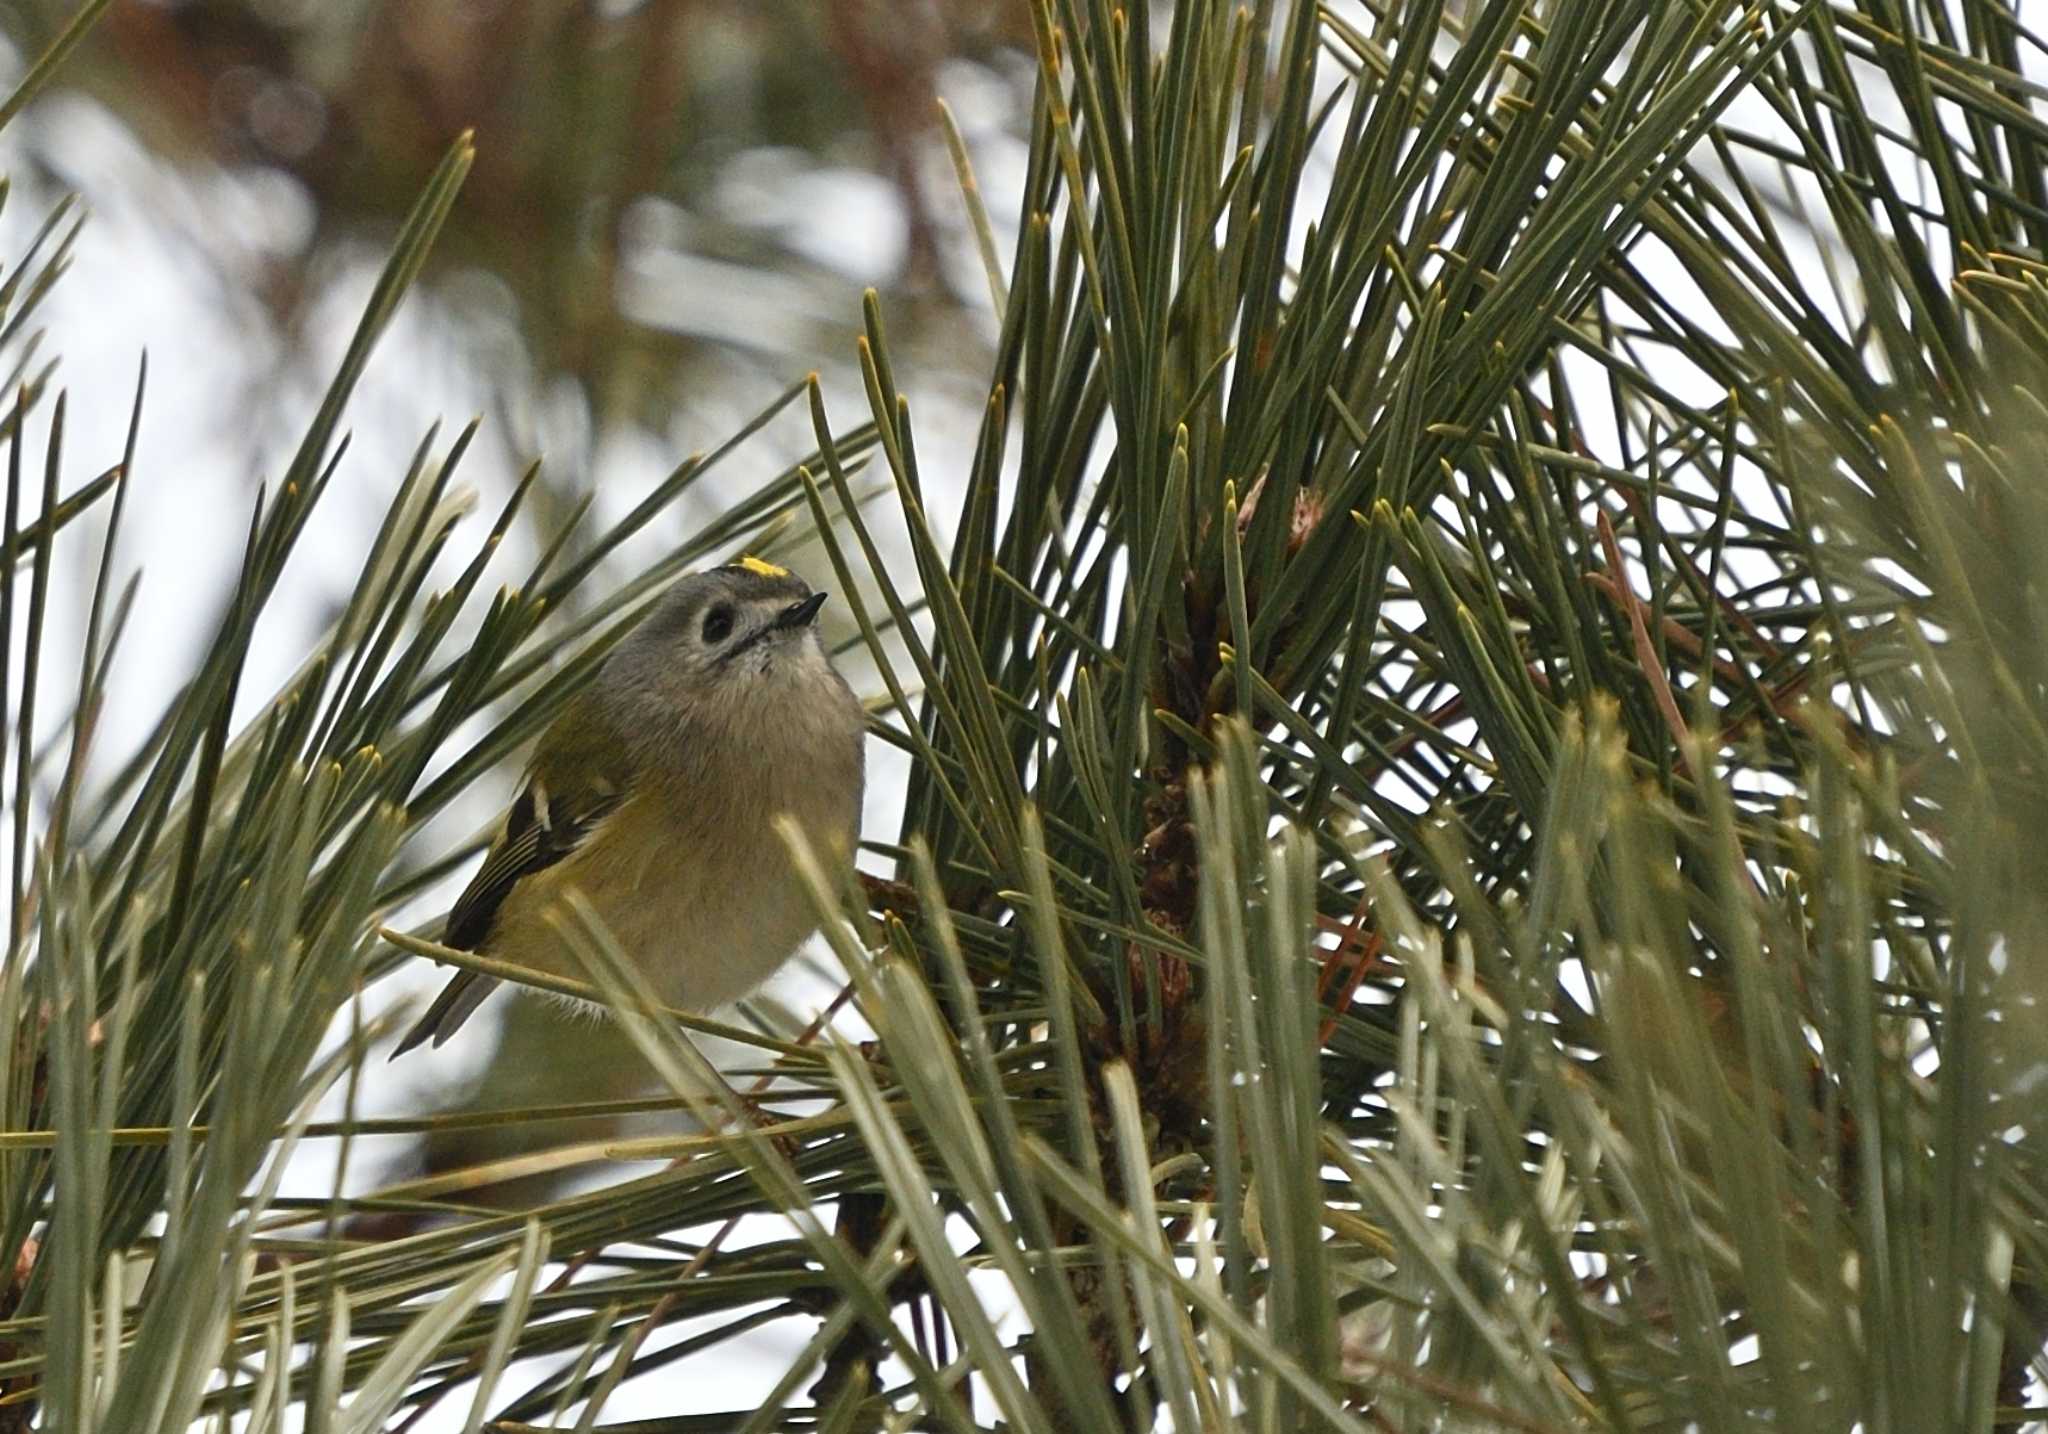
[[391, 729, 629, 1059]]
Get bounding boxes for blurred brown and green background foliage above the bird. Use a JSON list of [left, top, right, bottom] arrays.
[[4, 0, 1030, 411]]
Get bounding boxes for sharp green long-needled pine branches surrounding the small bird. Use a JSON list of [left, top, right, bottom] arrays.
[[0, 0, 2048, 1432]]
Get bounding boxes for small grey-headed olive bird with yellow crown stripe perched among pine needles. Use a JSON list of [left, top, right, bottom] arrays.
[[391, 557, 866, 1057]]
